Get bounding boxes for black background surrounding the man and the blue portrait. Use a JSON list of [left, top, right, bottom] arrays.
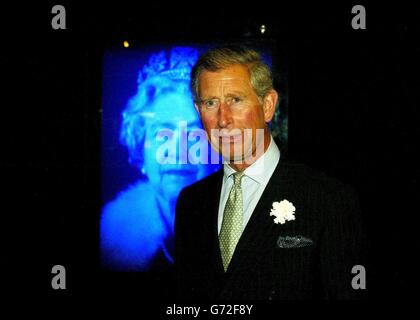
[[0, 3, 420, 303]]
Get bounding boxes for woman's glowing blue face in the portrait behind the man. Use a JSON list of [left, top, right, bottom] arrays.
[[143, 92, 207, 200]]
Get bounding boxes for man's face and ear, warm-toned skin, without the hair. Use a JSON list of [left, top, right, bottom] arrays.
[[196, 65, 277, 162]]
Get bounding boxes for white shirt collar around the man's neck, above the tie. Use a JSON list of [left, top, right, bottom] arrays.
[[223, 136, 280, 184]]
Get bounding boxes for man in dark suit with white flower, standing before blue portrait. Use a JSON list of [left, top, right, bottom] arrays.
[[175, 47, 363, 300]]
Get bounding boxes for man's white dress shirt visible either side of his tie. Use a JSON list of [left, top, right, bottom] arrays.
[[217, 137, 280, 233]]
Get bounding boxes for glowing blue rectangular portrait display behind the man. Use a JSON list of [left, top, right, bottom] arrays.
[[100, 46, 284, 271]]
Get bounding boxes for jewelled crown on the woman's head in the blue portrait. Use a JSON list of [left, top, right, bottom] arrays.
[[137, 47, 198, 85]]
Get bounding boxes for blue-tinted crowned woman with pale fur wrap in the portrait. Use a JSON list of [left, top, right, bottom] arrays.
[[100, 47, 217, 271]]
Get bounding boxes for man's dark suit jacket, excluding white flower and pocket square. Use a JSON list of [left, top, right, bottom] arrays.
[[175, 160, 364, 301]]
